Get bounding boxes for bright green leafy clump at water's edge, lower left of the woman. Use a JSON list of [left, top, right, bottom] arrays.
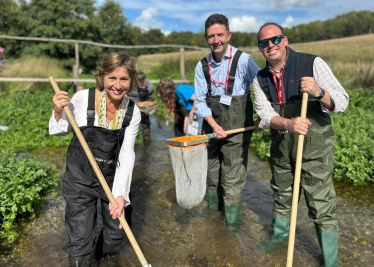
[[0, 150, 58, 242]]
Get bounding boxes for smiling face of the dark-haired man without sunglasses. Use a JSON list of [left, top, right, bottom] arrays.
[[205, 24, 231, 62]]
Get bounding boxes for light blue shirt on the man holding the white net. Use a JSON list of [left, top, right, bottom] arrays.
[[194, 45, 260, 117]]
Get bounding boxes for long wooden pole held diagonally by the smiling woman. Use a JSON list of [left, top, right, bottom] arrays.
[[49, 76, 148, 266]]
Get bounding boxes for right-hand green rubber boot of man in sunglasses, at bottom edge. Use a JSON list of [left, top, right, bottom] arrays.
[[317, 230, 339, 267]]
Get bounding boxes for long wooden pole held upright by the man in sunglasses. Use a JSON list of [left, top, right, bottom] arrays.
[[287, 93, 308, 267]]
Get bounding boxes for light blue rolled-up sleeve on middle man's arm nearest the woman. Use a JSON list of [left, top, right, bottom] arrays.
[[194, 61, 212, 118]]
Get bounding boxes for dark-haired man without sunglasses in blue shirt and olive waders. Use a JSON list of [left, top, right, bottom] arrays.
[[194, 14, 259, 224]]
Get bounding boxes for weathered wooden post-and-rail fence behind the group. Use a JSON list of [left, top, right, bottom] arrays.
[[0, 35, 209, 90]]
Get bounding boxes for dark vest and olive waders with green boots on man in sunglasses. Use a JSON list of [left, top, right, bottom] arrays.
[[257, 48, 338, 267]]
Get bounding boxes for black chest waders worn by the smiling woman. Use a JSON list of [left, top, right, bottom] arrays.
[[62, 89, 134, 266]]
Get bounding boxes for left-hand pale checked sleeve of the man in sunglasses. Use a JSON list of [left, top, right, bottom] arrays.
[[253, 77, 279, 129]]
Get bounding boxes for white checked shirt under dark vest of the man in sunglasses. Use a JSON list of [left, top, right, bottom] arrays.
[[253, 57, 349, 129]]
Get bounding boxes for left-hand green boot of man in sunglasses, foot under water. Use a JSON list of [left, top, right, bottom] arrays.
[[257, 216, 291, 252]]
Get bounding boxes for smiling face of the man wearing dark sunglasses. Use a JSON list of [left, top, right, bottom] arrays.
[[258, 25, 288, 69]]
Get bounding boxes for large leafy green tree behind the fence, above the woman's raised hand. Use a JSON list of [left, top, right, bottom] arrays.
[[20, 0, 102, 69]]
